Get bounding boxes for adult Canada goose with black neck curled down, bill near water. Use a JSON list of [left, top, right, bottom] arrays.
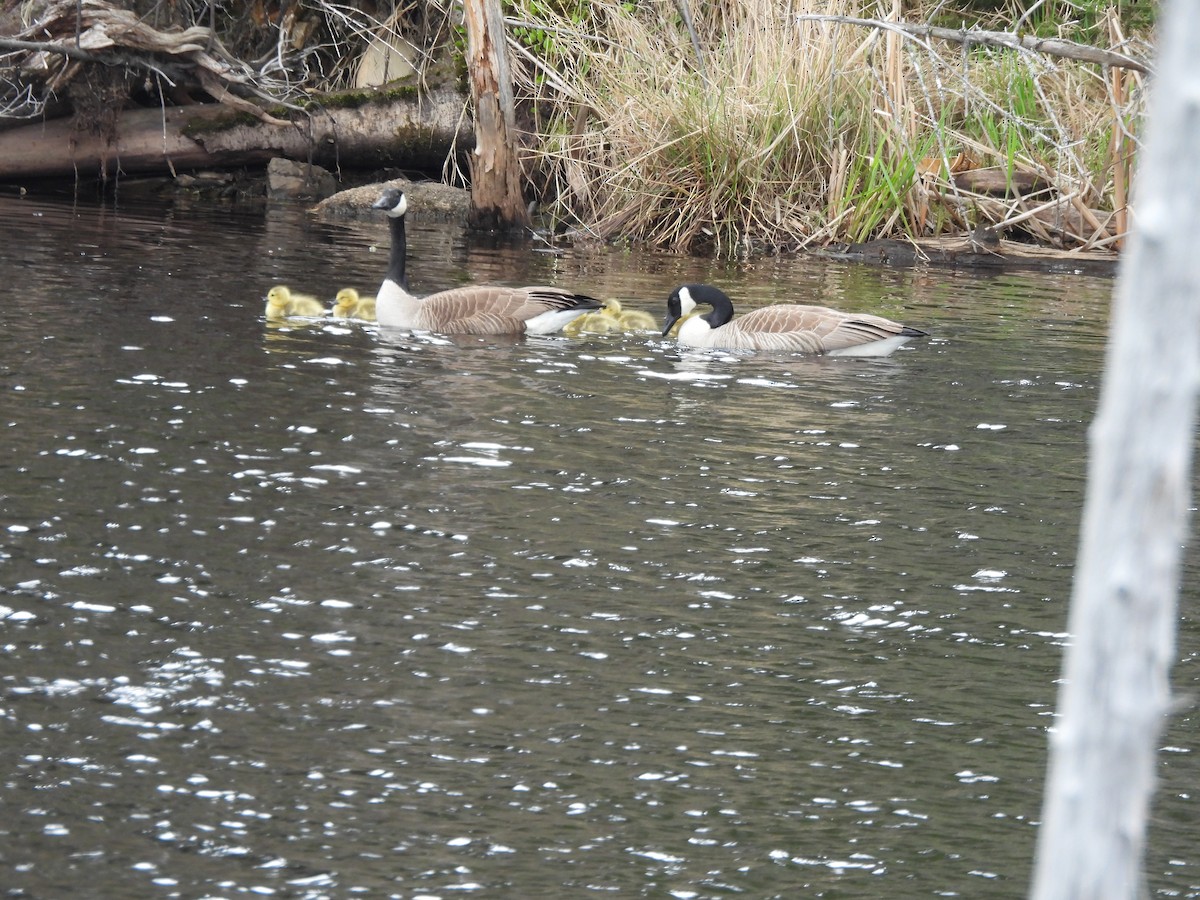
[[662, 284, 926, 356]]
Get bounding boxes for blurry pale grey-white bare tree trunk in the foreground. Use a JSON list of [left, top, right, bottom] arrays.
[[1032, 0, 1200, 900]]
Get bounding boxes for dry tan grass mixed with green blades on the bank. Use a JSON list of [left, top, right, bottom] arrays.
[[504, 0, 1142, 256]]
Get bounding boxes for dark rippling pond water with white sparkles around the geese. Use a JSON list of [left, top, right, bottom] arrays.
[[0, 187, 1200, 898]]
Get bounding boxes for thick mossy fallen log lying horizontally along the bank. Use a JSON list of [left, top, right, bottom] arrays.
[[0, 89, 472, 181]]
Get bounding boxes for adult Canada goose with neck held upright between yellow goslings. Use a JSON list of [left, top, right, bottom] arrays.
[[371, 187, 602, 335]]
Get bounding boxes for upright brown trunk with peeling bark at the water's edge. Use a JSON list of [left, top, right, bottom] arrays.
[[463, 0, 529, 230]]
